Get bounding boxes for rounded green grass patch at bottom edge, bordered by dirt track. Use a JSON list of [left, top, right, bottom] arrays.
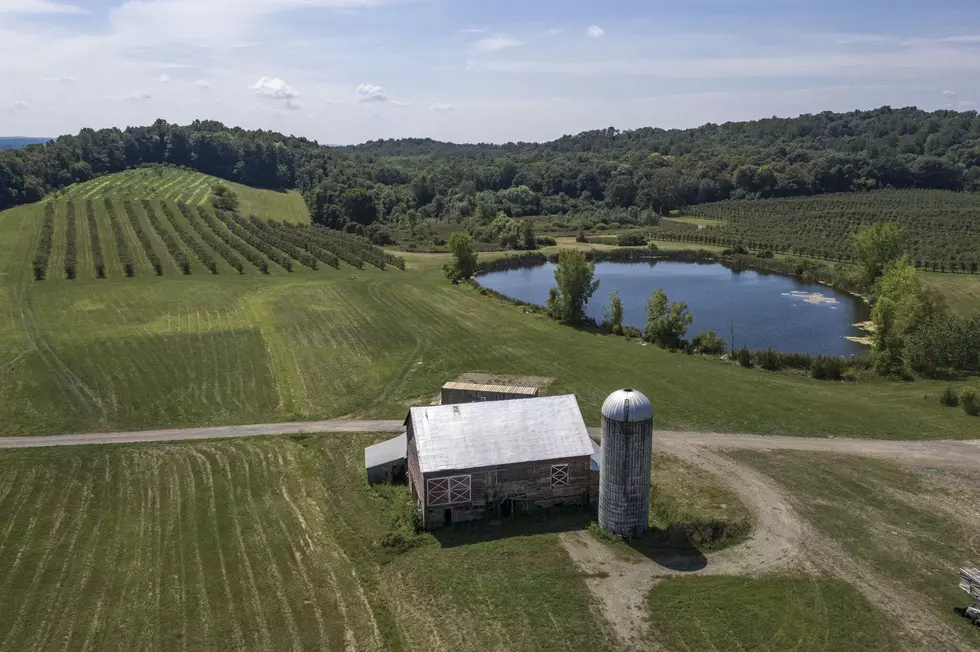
[[649, 577, 899, 652]]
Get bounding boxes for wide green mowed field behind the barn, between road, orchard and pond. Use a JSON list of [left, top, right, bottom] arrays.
[[0, 178, 980, 439]]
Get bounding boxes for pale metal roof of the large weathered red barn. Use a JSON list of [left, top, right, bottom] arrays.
[[409, 394, 593, 473]]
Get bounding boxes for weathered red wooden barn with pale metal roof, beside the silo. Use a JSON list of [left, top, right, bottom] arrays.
[[405, 395, 595, 529]]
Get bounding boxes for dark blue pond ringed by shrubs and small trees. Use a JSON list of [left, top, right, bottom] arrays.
[[477, 261, 869, 357]]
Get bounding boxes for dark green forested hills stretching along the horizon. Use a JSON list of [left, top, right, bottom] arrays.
[[0, 107, 980, 228]]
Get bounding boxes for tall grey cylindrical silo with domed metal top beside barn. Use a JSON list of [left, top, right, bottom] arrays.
[[599, 389, 653, 537]]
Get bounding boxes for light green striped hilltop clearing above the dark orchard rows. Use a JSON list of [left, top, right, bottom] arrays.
[[57, 166, 310, 224]]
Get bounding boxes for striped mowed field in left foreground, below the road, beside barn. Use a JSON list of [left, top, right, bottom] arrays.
[[0, 435, 612, 652]]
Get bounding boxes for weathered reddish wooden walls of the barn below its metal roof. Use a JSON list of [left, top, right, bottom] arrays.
[[420, 454, 591, 529]]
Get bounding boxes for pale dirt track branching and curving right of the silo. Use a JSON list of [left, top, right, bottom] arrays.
[[561, 432, 980, 652]]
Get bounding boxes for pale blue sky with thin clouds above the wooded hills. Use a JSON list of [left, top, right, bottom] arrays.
[[0, 0, 980, 144]]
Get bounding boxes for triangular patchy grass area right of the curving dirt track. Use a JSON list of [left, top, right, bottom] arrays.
[[730, 451, 980, 645]]
